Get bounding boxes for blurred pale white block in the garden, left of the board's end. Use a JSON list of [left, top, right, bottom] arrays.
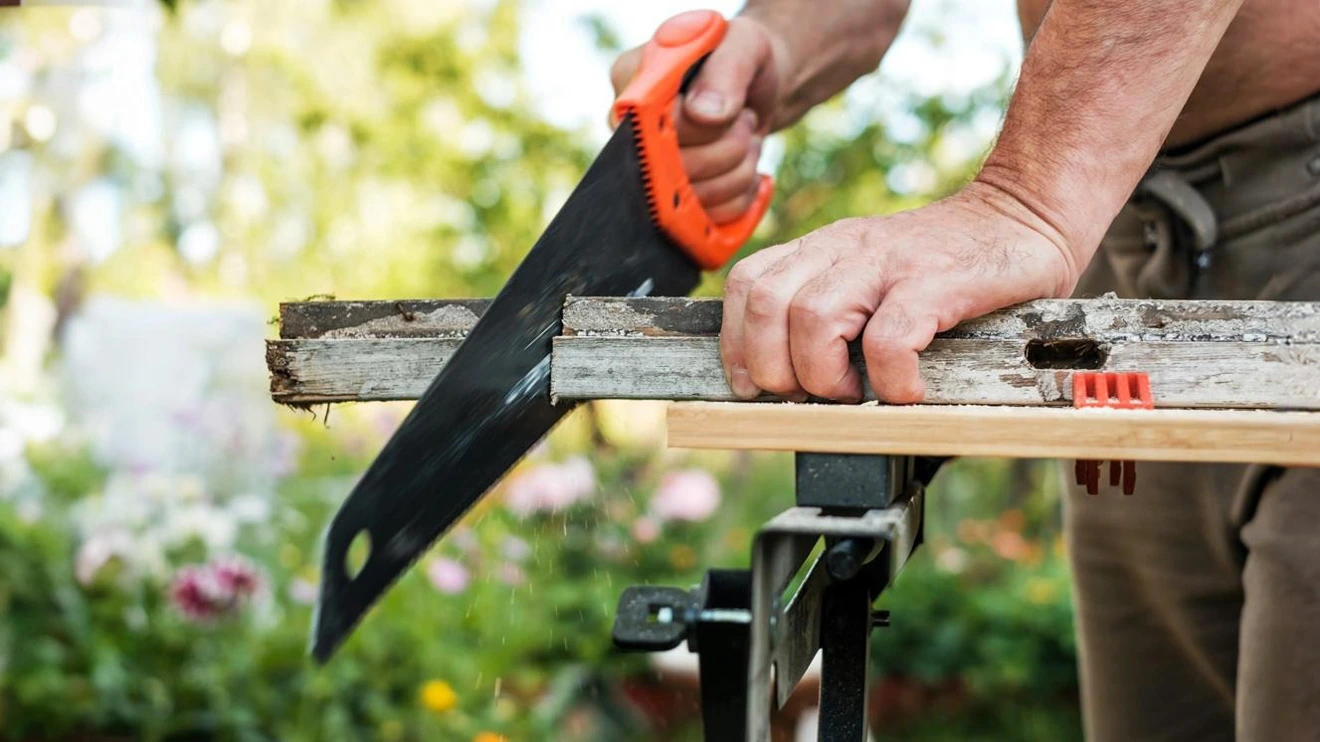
[[62, 297, 280, 495]]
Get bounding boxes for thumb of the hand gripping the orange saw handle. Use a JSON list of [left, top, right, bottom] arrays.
[[682, 20, 774, 125]]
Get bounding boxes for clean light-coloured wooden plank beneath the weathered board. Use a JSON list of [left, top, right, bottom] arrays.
[[668, 403, 1320, 466]]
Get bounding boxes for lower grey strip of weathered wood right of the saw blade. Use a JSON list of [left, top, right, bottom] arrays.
[[550, 335, 1320, 409]]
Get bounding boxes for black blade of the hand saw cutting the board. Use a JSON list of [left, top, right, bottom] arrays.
[[312, 118, 700, 661]]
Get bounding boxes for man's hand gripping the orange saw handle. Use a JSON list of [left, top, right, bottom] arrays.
[[610, 17, 788, 223]]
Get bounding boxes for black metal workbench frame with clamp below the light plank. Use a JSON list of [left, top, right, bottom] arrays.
[[614, 453, 942, 742]]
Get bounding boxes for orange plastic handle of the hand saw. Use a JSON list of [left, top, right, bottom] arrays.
[[614, 11, 774, 271]]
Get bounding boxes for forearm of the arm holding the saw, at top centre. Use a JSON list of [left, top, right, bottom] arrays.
[[741, 0, 908, 129]]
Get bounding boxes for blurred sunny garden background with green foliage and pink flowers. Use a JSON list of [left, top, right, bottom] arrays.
[[0, 0, 1080, 742]]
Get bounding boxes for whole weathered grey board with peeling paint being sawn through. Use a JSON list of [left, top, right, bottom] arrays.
[[267, 298, 1320, 409]]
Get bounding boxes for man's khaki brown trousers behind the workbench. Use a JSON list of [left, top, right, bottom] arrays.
[[1064, 96, 1320, 742]]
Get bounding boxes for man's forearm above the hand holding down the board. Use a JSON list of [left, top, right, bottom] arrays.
[[977, 0, 1243, 283]]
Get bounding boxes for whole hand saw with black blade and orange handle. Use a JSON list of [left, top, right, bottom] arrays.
[[312, 11, 772, 661]]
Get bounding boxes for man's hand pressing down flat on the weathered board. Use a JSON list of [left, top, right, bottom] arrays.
[[719, 182, 1080, 403]]
